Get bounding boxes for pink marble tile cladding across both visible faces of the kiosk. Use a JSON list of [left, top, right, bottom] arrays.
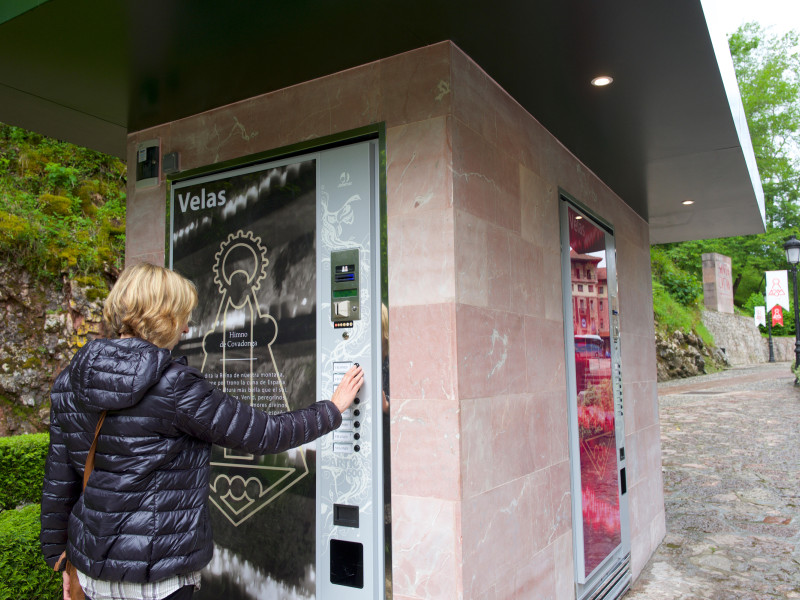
[[126, 42, 664, 600]]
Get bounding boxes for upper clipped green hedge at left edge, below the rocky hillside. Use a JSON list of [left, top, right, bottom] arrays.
[[0, 433, 50, 509]]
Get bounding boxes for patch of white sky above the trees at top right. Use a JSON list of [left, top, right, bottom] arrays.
[[703, 0, 800, 35]]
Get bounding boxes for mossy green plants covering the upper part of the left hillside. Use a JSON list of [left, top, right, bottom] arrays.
[[0, 123, 126, 290]]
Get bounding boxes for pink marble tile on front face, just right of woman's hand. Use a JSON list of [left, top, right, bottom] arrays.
[[389, 304, 456, 403]]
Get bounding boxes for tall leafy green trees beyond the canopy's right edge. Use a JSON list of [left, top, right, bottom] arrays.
[[654, 23, 800, 306]]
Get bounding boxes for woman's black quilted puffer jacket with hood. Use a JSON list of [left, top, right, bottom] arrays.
[[40, 338, 341, 583]]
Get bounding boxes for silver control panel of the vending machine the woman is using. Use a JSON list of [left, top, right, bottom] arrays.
[[315, 141, 386, 600]]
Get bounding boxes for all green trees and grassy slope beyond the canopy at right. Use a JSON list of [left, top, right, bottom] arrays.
[[651, 23, 800, 350]]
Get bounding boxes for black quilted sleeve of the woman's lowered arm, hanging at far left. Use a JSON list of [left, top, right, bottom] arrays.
[[39, 392, 82, 567]]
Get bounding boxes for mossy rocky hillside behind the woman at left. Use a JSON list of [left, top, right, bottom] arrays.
[[0, 123, 126, 435]]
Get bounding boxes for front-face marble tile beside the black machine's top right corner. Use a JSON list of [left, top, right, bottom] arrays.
[[386, 117, 453, 219]]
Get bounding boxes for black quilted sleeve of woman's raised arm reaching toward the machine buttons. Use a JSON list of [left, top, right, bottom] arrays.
[[174, 369, 342, 454]]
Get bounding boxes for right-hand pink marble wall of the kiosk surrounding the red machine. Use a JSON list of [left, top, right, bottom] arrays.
[[451, 47, 664, 598]]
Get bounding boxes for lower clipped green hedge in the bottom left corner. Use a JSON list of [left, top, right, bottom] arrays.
[[0, 504, 61, 600]]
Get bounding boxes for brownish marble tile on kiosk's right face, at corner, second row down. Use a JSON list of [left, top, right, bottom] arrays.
[[452, 119, 521, 232]]
